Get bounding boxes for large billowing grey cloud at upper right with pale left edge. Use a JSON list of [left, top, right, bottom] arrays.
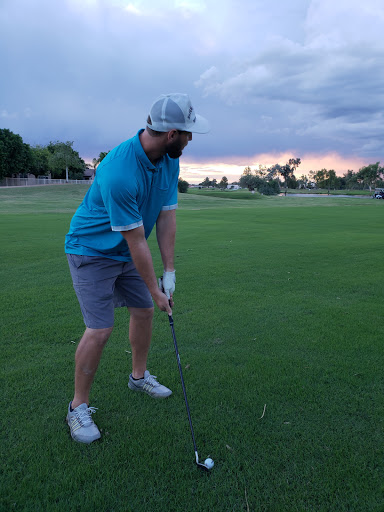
[[195, 1, 384, 157]]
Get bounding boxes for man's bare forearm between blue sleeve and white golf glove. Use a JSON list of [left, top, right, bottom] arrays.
[[156, 210, 176, 272]]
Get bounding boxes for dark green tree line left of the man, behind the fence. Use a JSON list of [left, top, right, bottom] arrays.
[[0, 128, 108, 180]]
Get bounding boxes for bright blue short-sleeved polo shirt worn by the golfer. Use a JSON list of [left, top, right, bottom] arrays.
[[65, 130, 179, 261]]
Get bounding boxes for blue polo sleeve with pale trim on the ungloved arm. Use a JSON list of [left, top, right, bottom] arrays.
[[100, 163, 143, 231]]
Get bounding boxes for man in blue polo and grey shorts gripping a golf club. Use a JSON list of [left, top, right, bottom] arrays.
[[65, 93, 209, 443]]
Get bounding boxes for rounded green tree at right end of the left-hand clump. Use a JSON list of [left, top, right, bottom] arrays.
[[47, 141, 85, 181]]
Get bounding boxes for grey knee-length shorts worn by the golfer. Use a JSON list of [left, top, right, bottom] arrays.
[[67, 254, 153, 329]]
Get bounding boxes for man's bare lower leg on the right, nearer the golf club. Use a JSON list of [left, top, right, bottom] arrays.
[[128, 308, 154, 379]]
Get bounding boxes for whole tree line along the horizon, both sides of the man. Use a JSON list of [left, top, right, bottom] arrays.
[[0, 128, 384, 195]]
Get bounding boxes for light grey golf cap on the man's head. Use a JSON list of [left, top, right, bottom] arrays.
[[147, 92, 210, 133]]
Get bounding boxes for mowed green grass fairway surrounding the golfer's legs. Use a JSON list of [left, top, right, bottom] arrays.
[[0, 185, 384, 512]]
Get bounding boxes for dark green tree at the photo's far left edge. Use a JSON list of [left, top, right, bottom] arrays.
[[0, 128, 32, 179]]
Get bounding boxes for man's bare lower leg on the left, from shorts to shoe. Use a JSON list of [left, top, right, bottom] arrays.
[[72, 327, 113, 409]]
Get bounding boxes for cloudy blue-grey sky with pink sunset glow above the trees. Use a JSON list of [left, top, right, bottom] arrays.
[[0, 0, 384, 183]]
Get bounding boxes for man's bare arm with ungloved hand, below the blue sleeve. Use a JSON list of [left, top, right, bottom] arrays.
[[121, 226, 172, 315]]
